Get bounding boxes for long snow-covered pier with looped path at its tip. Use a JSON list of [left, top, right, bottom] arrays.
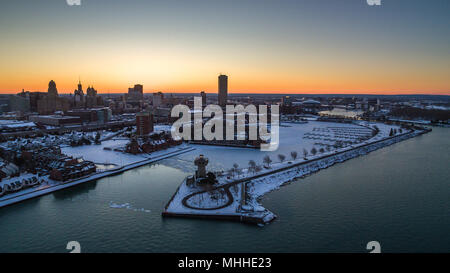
[[162, 126, 431, 224]]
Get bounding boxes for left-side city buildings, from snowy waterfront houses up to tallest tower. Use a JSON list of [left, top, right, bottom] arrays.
[[0, 75, 232, 186]]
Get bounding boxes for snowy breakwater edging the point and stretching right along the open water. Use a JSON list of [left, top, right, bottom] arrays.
[[162, 129, 431, 224]]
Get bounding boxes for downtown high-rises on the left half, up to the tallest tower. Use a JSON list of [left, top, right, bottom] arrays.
[[0, 75, 232, 134]]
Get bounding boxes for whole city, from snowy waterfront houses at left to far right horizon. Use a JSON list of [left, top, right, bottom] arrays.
[[0, 72, 450, 190]]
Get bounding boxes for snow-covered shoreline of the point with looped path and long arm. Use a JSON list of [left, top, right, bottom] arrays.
[[163, 126, 428, 224]]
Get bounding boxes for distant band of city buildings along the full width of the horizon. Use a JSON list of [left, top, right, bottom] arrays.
[[0, 75, 448, 135]]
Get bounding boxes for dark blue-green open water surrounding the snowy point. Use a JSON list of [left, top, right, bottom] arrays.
[[0, 128, 450, 252]]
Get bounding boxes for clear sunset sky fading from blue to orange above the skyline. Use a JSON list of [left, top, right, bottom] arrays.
[[0, 0, 450, 95]]
